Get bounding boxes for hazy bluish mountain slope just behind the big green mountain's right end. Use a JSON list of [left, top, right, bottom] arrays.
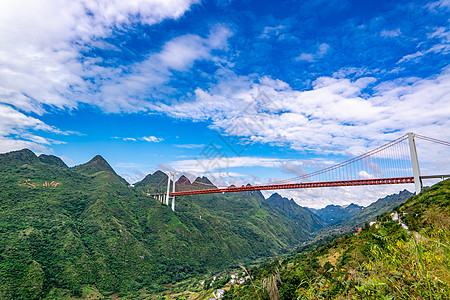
[[266, 193, 325, 232]]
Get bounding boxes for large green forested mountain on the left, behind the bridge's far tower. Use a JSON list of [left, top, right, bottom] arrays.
[[0, 149, 309, 299]]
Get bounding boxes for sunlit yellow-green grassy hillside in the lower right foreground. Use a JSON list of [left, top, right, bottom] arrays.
[[223, 180, 450, 299]]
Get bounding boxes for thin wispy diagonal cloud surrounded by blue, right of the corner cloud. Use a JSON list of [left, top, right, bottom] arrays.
[[98, 26, 231, 113]]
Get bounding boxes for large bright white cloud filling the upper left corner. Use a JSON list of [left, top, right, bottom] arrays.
[[0, 0, 200, 151]]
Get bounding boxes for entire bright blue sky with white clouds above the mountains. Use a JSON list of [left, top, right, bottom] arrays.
[[0, 0, 450, 207]]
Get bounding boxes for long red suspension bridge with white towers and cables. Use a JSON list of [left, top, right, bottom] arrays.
[[148, 133, 450, 210]]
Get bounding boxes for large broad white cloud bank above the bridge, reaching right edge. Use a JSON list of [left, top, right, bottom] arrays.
[[150, 69, 450, 155]]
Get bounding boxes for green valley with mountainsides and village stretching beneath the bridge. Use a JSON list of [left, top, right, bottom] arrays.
[[0, 149, 446, 299]]
